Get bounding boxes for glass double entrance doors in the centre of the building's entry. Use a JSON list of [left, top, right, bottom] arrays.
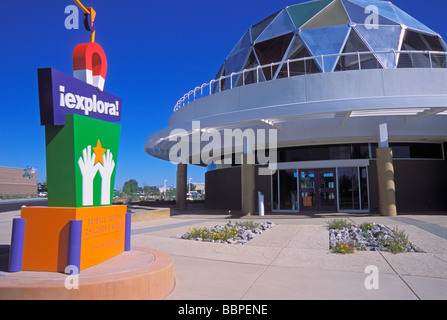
[[299, 169, 337, 211]]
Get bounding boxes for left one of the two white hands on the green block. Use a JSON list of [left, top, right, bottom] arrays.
[[78, 146, 99, 206]]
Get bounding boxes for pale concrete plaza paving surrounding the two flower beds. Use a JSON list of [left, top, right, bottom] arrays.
[[127, 212, 447, 300]]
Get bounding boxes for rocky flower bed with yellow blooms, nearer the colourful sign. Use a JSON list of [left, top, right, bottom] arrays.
[[175, 221, 275, 244]]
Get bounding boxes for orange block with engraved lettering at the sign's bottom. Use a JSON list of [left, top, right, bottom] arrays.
[[22, 206, 127, 272]]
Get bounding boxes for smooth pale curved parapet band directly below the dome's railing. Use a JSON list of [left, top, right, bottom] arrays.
[[169, 69, 447, 126]]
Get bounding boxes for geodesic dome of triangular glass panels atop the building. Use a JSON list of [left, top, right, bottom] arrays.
[[213, 0, 447, 92]]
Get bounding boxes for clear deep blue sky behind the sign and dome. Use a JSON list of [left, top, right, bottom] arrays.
[[0, 0, 447, 189]]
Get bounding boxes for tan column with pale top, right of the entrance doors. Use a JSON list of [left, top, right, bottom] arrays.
[[376, 124, 397, 216]]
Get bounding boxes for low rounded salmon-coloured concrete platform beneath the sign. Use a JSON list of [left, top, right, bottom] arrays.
[[0, 248, 174, 300]]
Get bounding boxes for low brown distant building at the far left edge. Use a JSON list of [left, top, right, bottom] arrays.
[[0, 167, 37, 198]]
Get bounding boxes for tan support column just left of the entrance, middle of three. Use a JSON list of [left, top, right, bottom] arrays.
[[241, 154, 256, 216]]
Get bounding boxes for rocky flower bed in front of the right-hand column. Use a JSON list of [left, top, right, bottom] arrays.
[[328, 219, 424, 253]]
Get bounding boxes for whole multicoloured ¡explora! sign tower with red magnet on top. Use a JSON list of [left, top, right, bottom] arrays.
[[9, 0, 130, 272]]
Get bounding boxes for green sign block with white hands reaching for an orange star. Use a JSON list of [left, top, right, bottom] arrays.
[[45, 114, 121, 208]]
